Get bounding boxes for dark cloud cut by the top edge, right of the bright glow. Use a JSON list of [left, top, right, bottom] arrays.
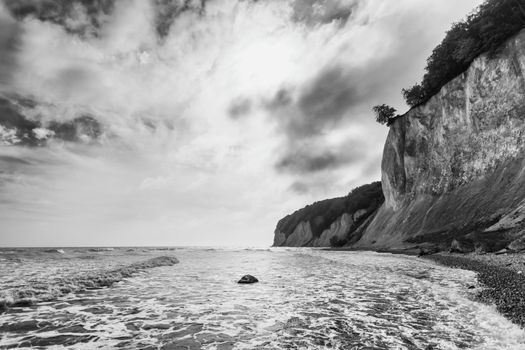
[[292, 0, 358, 26]]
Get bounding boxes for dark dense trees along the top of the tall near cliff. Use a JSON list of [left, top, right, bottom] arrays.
[[403, 0, 525, 107]]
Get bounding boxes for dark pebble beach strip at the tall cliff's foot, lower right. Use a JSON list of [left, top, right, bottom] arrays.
[[422, 253, 525, 328]]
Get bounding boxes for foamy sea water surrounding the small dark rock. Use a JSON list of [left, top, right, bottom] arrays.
[[0, 247, 525, 350]]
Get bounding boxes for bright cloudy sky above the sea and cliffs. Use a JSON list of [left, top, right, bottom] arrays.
[[0, 0, 481, 246]]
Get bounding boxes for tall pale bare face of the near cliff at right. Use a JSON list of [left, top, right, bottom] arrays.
[[355, 31, 525, 250]]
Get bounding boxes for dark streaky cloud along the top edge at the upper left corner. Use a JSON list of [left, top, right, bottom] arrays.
[[4, 0, 115, 36]]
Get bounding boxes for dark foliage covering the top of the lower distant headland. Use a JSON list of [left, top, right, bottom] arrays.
[[277, 181, 385, 237]]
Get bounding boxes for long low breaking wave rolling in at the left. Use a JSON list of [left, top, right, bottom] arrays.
[[0, 256, 179, 310]]
